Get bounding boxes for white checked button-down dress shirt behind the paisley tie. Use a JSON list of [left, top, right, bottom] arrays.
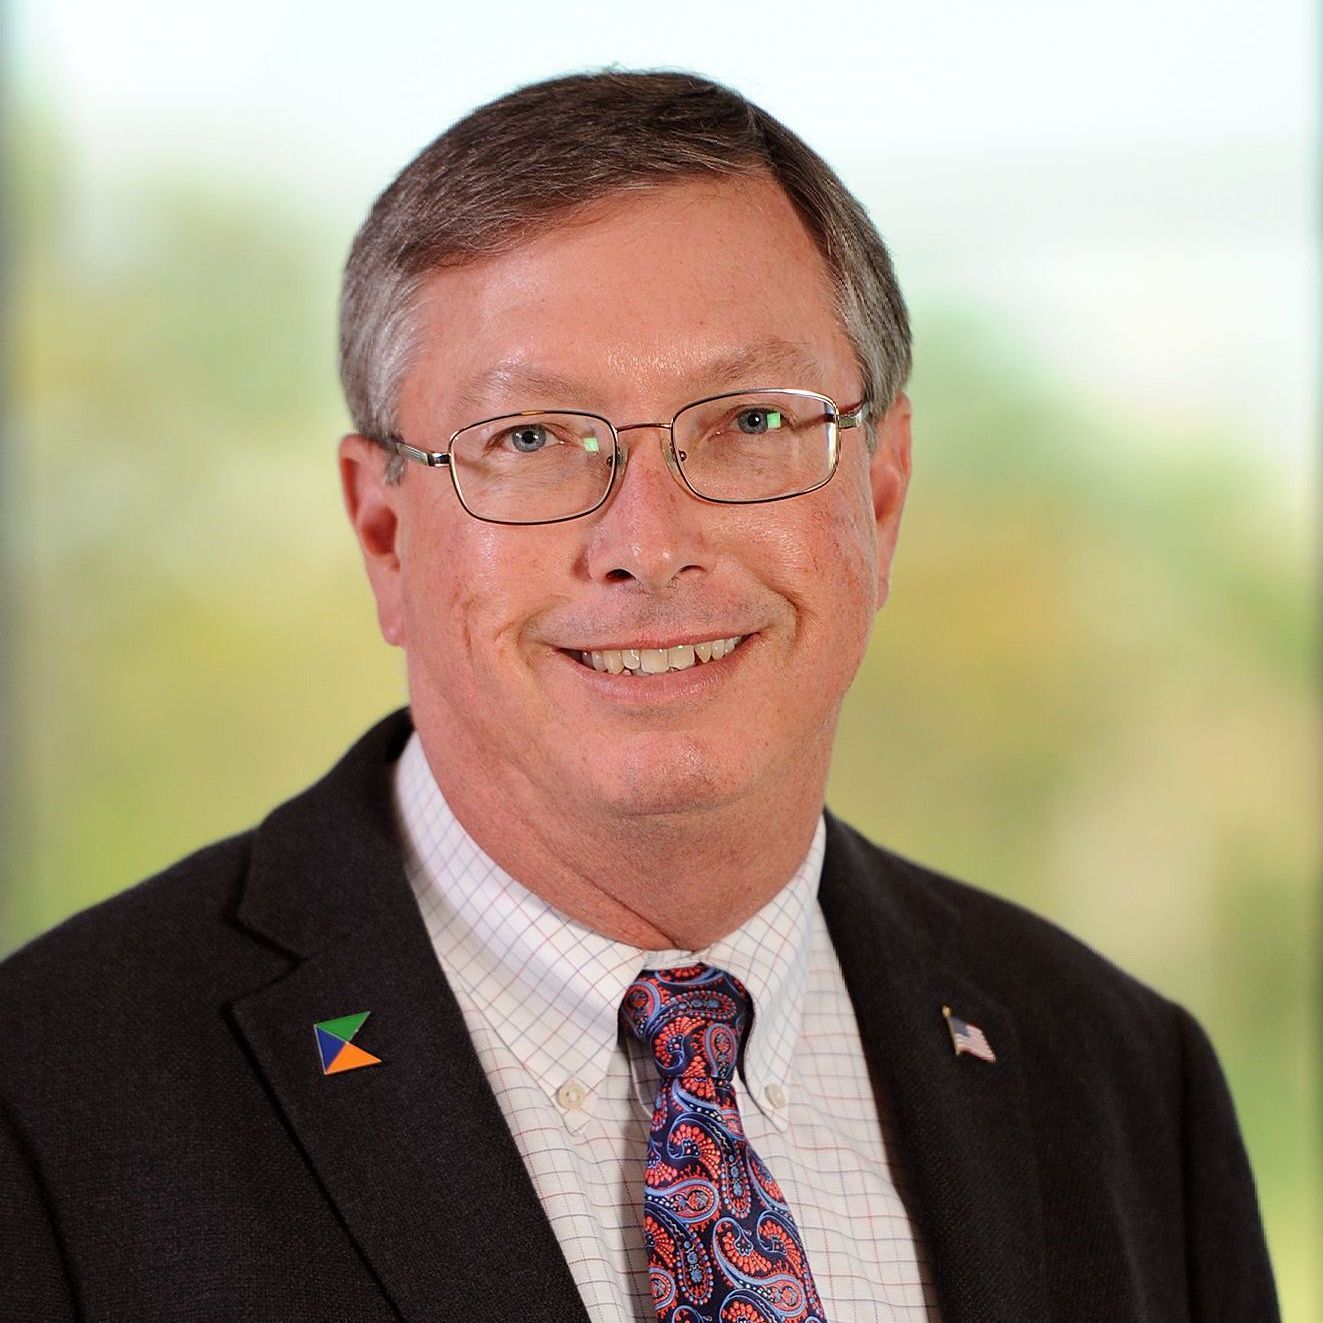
[[396, 734, 938, 1323]]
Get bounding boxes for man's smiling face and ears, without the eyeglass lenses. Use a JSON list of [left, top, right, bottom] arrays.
[[343, 176, 909, 830]]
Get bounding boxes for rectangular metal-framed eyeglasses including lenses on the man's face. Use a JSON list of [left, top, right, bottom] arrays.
[[381, 389, 868, 524]]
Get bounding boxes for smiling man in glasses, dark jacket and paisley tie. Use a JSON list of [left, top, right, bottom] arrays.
[[0, 73, 1275, 1323]]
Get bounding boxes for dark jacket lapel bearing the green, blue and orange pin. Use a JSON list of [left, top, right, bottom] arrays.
[[233, 717, 587, 1323]]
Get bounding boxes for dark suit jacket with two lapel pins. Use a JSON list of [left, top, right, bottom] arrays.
[[0, 713, 1277, 1323]]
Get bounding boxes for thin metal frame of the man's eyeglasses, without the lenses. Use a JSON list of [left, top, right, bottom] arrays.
[[380, 386, 869, 528]]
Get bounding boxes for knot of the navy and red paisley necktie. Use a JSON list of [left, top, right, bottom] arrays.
[[620, 964, 751, 1081]]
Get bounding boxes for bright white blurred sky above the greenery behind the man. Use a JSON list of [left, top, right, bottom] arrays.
[[9, 0, 1318, 500]]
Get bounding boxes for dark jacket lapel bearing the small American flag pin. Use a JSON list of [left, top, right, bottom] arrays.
[[820, 818, 1048, 1323]]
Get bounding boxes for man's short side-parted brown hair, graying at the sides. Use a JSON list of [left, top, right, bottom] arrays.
[[340, 70, 910, 480]]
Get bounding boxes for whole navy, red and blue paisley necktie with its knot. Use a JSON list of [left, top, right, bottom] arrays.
[[620, 964, 826, 1323]]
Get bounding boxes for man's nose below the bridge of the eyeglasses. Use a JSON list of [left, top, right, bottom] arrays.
[[587, 423, 712, 593]]
